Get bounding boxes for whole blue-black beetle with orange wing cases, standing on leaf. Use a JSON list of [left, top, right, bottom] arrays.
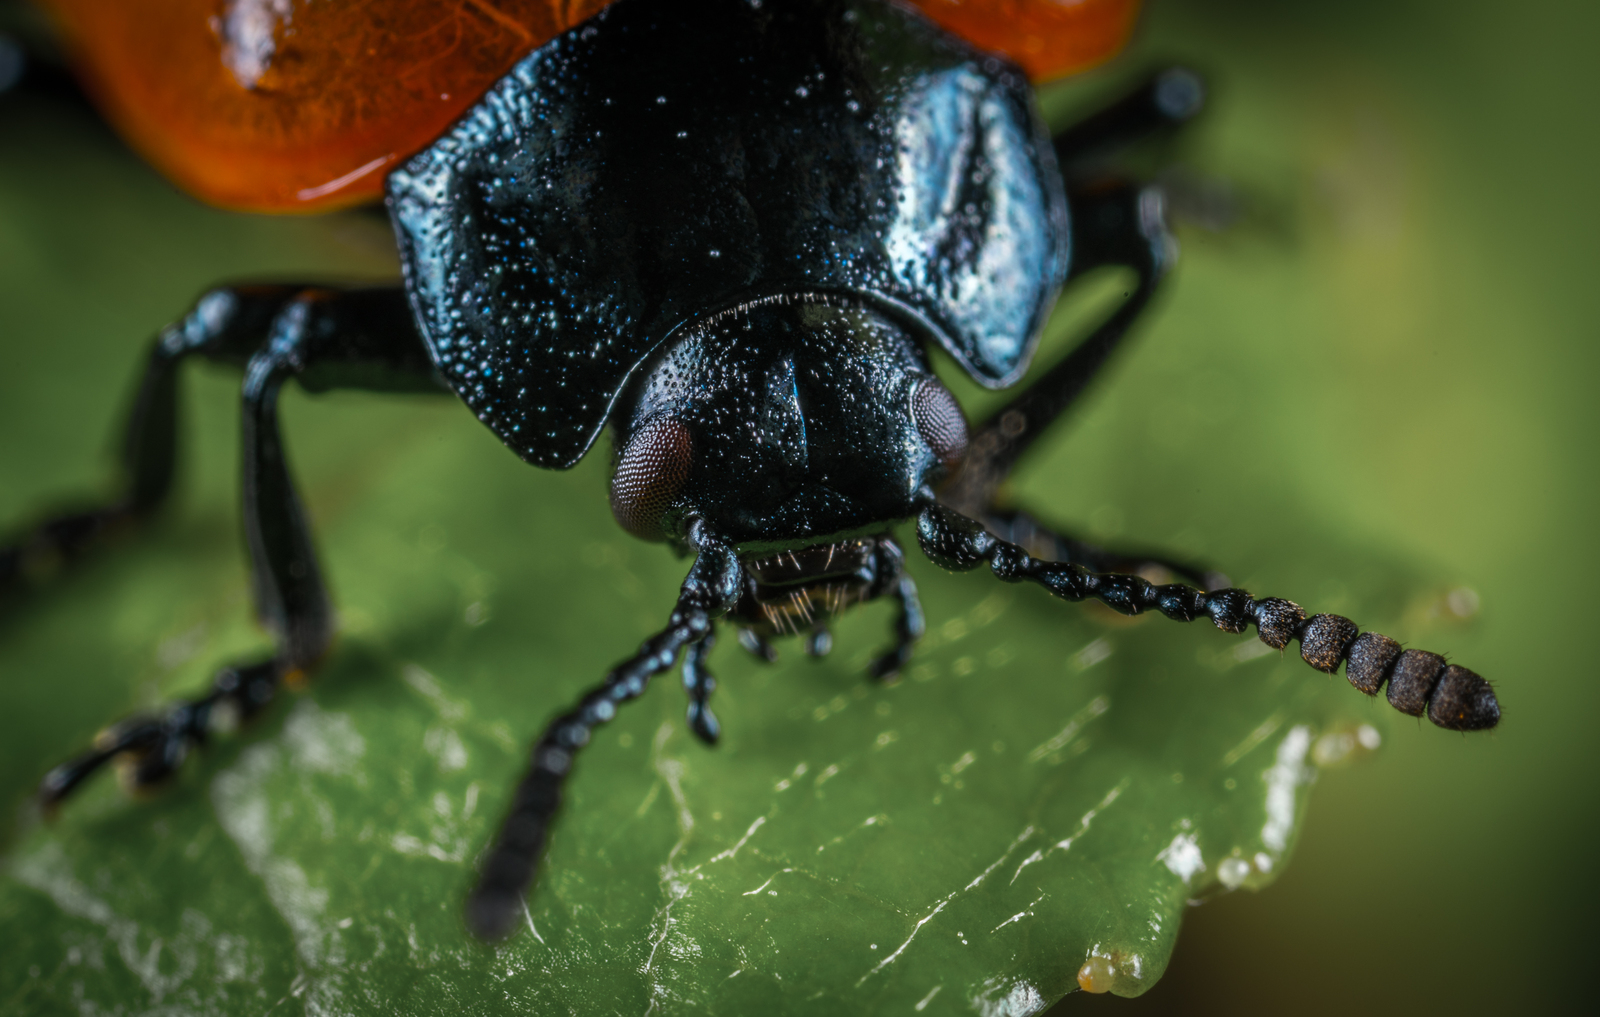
[[0, 0, 1499, 939]]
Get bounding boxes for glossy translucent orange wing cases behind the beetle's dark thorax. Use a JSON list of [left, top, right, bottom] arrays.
[[40, 0, 1139, 213]]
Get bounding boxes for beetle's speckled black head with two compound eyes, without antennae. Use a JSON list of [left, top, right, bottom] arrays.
[[611, 297, 966, 544]]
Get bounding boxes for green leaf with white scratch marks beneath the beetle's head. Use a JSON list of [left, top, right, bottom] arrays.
[[0, 431, 1388, 1014]]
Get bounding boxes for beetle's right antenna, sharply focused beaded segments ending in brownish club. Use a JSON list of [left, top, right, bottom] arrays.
[[917, 505, 1499, 731]]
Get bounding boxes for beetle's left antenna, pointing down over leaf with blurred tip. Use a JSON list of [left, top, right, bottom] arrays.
[[467, 521, 742, 939]]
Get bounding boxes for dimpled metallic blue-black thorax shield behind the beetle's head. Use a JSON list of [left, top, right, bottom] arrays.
[[389, 2, 1069, 467]]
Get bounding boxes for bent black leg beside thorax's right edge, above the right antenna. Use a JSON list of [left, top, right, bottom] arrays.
[[939, 182, 1173, 515]]
